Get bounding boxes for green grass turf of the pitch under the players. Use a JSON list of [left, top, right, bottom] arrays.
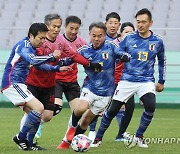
[[0, 108, 180, 154]]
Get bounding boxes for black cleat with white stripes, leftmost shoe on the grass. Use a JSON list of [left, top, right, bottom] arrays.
[[12, 135, 30, 151]]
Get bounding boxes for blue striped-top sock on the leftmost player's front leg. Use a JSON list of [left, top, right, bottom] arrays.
[[18, 110, 41, 140]]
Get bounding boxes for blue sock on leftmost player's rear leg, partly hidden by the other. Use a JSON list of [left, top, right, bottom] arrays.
[[27, 122, 40, 146]]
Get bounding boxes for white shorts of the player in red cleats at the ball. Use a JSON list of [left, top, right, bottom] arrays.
[[80, 88, 111, 115]]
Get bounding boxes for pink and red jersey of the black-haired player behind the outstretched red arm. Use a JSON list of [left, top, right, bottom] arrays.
[[56, 34, 87, 82]]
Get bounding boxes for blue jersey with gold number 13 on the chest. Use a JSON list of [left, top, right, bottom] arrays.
[[119, 31, 166, 84]]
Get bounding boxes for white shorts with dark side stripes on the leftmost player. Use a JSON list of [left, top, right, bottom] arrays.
[[2, 83, 34, 106]]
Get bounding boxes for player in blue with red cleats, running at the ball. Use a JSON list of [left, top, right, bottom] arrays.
[[58, 22, 129, 149]]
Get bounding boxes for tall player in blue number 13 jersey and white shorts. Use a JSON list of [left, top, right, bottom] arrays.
[[92, 8, 166, 148]]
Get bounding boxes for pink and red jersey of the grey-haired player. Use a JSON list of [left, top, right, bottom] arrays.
[[26, 35, 89, 88]]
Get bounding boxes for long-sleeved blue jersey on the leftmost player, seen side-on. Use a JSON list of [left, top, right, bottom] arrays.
[[2, 37, 54, 89]]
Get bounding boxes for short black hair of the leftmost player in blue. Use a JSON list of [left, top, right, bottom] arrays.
[[28, 23, 48, 37]]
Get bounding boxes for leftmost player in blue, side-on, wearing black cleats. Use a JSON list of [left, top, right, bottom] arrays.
[[2, 23, 61, 150]]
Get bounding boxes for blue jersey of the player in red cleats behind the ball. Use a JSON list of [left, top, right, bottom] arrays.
[[78, 40, 122, 96]]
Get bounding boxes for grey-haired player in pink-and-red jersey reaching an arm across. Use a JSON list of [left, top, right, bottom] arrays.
[[21, 14, 100, 141]]
